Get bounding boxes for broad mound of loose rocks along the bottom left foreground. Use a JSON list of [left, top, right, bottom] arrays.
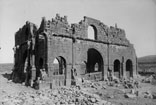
[[0, 87, 114, 105]]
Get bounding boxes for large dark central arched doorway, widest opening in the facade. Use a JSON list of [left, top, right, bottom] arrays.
[[87, 48, 104, 79]]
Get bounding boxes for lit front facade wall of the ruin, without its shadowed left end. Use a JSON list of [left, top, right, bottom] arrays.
[[36, 15, 136, 84]]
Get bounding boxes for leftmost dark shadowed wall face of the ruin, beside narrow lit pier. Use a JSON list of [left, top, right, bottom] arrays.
[[14, 23, 29, 81]]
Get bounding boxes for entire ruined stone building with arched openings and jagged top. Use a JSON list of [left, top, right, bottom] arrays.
[[13, 14, 137, 86]]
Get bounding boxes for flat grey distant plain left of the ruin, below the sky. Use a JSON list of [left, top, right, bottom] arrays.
[[0, 63, 13, 72]]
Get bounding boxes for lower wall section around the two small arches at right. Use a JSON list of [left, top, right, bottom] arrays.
[[109, 45, 137, 77]]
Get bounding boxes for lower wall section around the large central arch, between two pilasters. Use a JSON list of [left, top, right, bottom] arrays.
[[75, 40, 108, 78]]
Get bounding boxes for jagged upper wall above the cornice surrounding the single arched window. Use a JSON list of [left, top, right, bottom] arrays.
[[71, 16, 130, 46]]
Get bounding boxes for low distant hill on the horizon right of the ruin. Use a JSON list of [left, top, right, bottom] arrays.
[[138, 55, 156, 63]]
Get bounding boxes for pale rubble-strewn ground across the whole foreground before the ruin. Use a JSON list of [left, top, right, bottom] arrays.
[[0, 69, 156, 105]]
